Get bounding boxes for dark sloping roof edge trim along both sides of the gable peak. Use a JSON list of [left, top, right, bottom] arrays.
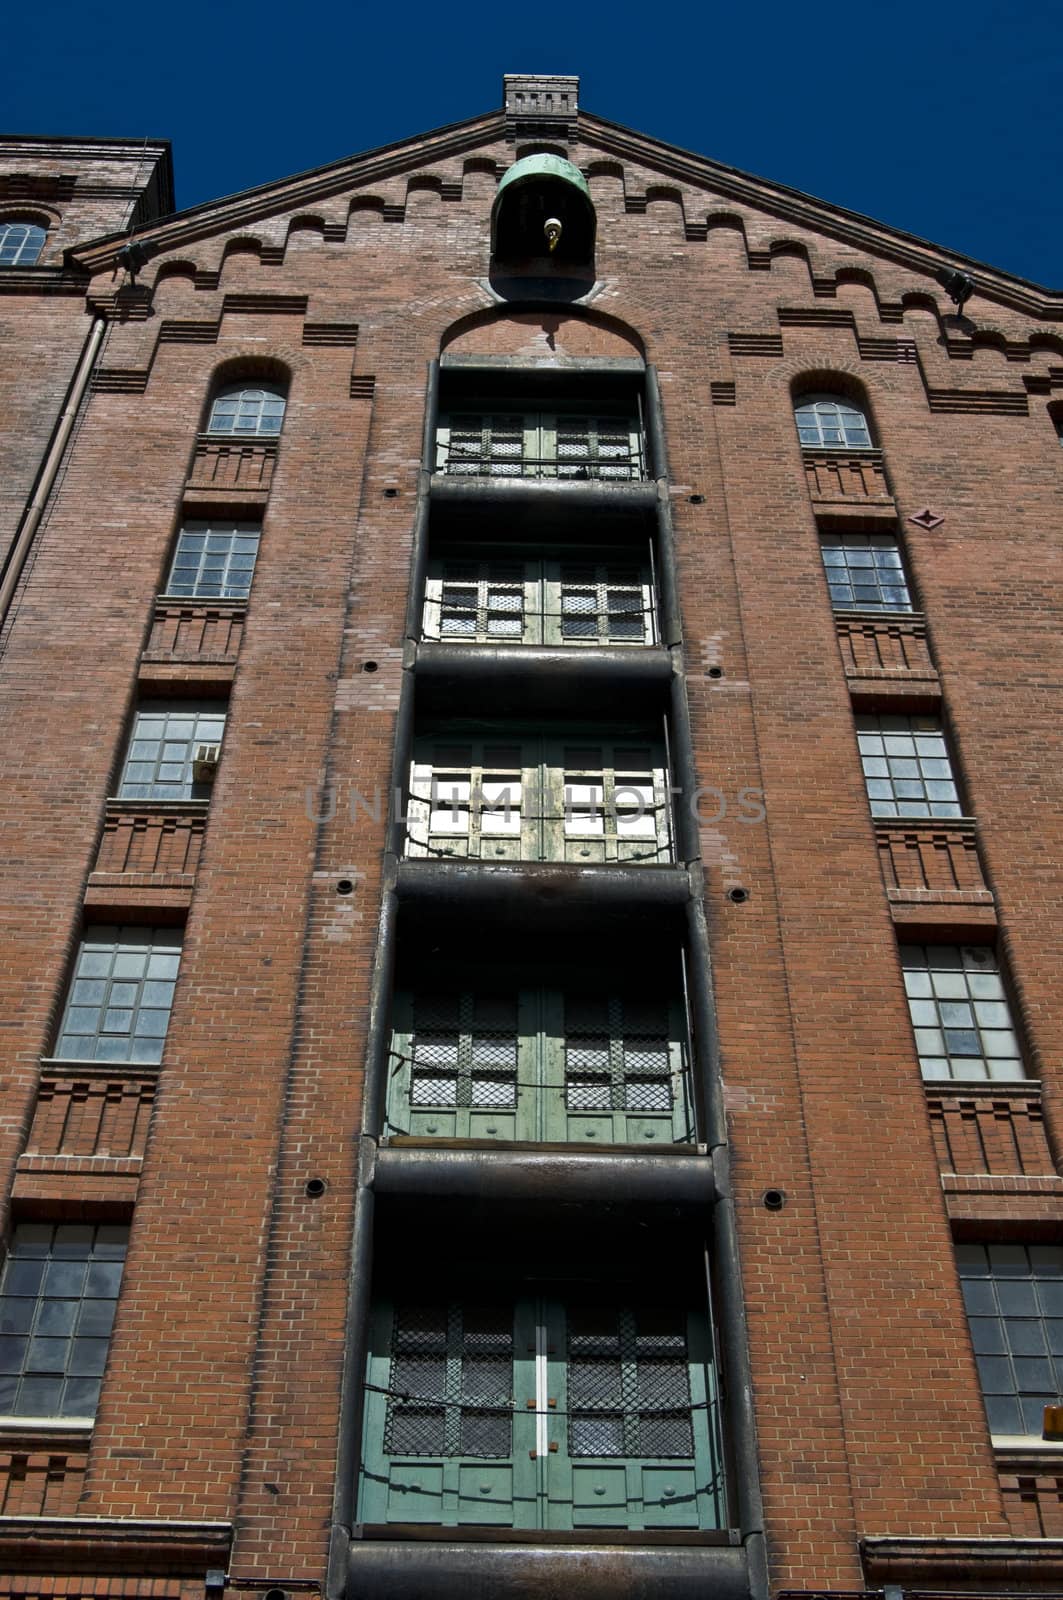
[[67, 99, 1063, 322]]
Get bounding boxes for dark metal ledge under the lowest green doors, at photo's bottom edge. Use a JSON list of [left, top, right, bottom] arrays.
[[346, 1534, 749, 1600]]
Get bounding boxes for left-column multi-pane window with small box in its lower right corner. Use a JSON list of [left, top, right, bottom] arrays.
[[118, 701, 226, 800]]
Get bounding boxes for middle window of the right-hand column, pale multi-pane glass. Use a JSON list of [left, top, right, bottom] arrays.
[[856, 712, 964, 816]]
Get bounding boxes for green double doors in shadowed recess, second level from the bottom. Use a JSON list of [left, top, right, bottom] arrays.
[[386, 981, 693, 1144]]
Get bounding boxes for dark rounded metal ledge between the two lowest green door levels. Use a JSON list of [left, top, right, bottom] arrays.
[[371, 1144, 716, 1206]]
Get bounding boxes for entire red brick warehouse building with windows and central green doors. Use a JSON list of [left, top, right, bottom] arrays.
[[0, 78, 1063, 1600]]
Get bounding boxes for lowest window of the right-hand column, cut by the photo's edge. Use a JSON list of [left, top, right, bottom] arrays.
[[956, 1245, 1063, 1440]]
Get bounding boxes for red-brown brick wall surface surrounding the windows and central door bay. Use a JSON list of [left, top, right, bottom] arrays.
[[0, 84, 1063, 1600]]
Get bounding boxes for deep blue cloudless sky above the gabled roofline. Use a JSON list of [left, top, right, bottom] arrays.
[[0, 0, 1063, 288]]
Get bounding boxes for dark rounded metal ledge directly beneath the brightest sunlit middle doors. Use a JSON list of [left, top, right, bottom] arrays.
[[395, 856, 692, 910]]
